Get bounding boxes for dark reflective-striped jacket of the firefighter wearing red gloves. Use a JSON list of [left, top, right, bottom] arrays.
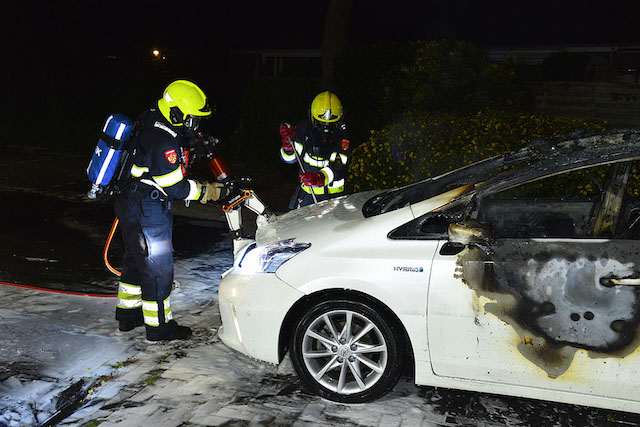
[[280, 121, 351, 208]]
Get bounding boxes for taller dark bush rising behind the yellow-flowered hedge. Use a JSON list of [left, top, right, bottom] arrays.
[[336, 41, 522, 143]]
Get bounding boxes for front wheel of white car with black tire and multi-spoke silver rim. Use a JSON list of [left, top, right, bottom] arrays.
[[291, 300, 403, 403]]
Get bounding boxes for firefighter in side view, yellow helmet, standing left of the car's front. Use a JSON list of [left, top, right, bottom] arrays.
[[115, 80, 225, 341]]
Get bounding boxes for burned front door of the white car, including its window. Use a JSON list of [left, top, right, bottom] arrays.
[[427, 131, 640, 401]]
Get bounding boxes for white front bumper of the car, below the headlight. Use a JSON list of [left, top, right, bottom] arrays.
[[218, 267, 304, 364]]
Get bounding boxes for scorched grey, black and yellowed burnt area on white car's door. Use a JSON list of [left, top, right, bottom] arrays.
[[459, 239, 640, 378]]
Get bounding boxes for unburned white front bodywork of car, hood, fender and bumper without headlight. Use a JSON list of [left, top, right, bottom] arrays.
[[219, 193, 451, 363]]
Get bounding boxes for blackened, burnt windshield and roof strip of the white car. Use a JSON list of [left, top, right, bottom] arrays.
[[362, 128, 640, 217]]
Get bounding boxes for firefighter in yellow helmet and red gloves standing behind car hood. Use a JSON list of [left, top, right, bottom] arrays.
[[280, 92, 351, 209]]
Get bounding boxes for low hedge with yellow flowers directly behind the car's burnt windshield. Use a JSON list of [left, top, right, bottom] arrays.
[[348, 110, 606, 191]]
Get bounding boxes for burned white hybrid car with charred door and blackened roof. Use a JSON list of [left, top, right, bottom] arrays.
[[219, 130, 640, 412]]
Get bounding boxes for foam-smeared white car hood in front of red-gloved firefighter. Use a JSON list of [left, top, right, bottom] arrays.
[[256, 190, 382, 245]]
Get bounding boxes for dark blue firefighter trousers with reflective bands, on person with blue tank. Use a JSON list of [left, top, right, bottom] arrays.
[[114, 192, 173, 333]]
